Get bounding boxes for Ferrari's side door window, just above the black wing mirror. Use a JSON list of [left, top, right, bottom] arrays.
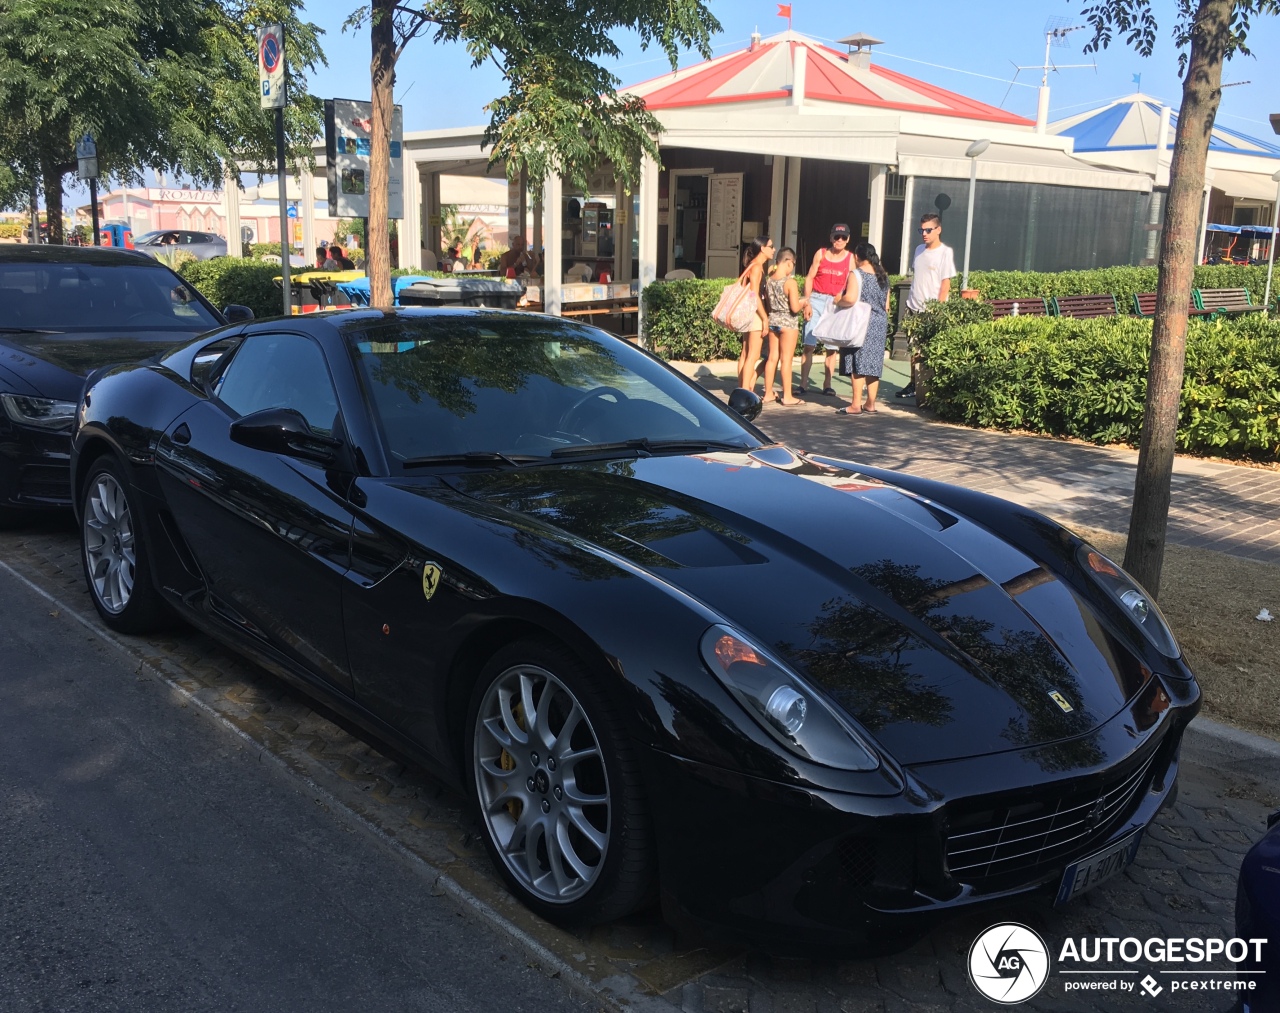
[[212, 334, 338, 434]]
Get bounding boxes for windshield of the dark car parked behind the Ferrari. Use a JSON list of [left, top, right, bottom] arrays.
[[0, 261, 220, 334]]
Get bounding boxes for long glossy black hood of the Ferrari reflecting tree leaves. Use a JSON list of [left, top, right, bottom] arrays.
[[451, 447, 1149, 763]]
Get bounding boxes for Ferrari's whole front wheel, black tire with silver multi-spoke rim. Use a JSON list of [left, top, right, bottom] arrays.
[[466, 640, 653, 925]]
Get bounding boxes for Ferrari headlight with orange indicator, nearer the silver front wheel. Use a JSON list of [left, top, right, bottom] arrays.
[[701, 626, 879, 771]]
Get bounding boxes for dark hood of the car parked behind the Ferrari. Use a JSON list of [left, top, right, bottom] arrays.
[[0, 330, 198, 401]]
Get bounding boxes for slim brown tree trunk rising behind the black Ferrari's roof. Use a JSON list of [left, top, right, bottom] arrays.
[[365, 0, 391, 309]]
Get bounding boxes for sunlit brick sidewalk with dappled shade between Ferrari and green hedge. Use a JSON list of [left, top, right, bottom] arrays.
[[672, 361, 1280, 563]]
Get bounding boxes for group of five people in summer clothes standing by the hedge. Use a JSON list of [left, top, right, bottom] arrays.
[[737, 214, 956, 416]]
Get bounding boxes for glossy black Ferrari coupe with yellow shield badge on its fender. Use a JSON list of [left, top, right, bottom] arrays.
[[73, 309, 1199, 943]]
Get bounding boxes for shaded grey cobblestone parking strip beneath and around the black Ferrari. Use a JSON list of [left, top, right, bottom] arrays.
[[0, 507, 1280, 1013]]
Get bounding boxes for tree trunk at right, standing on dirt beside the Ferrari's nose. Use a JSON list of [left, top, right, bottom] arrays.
[[1124, 0, 1235, 596]]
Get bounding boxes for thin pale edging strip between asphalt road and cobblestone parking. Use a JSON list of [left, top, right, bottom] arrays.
[[0, 560, 676, 1013]]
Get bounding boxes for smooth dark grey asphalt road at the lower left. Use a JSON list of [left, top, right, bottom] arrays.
[[0, 572, 582, 1013]]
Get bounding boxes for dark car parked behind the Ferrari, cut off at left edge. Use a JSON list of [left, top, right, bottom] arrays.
[[0, 245, 253, 524]]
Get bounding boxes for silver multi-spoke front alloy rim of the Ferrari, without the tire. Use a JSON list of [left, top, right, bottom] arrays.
[[472, 665, 611, 904]]
